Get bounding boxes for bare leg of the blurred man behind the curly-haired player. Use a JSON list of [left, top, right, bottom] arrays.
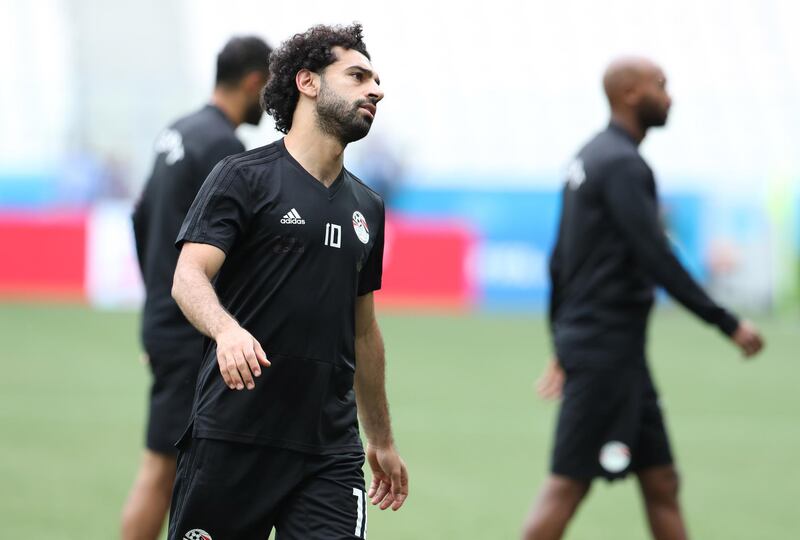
[[122, 450, 176, 540]]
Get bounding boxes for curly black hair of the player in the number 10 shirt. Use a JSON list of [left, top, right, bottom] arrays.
[[261, 23, 370, 133]]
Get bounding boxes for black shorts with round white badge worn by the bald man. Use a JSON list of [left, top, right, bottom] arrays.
[[551, 362, 673, 480]]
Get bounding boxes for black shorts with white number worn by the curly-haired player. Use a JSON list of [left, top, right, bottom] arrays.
[[168, 436, 367, 540]]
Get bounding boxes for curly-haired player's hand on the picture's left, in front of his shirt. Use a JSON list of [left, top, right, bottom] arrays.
[[215, 321, 270, 390]]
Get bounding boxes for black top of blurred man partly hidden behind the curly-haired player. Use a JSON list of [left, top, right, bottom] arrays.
[[133, 105, 244, 361]]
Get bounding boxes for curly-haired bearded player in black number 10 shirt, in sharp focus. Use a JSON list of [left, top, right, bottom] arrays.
[[169, 25, 408, 540]]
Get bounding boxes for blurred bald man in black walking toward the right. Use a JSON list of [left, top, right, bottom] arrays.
[[523, 58, 763, 540]]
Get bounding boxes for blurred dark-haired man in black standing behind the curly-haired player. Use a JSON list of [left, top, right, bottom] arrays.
[[122, 37, 270, 540]]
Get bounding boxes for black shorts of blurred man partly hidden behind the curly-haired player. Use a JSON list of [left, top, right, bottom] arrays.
[[145, 354, 202, 456]]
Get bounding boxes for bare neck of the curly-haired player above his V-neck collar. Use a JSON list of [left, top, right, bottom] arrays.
[[283, 119, 344, 187]]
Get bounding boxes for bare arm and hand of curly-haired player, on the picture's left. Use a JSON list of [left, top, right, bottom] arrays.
[[172, 242, 270, 390]]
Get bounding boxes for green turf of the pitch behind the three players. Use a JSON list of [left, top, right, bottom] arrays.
[[0, 304, 800, 540]]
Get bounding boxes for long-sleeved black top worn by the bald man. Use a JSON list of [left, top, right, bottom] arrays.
[[550, 123, 738, 365]]
